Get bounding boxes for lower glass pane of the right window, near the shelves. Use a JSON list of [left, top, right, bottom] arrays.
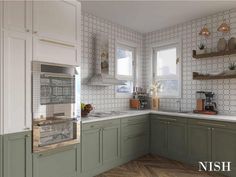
[[158, 80, 179, 96]]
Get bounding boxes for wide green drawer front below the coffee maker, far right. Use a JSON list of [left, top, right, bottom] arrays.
[[188, 119, 236, 129]]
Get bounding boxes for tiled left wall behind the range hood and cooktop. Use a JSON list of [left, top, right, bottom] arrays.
[[81, 13, 143, 111]]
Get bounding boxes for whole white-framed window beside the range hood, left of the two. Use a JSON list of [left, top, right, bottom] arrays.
[[116, 43, 135, 95]]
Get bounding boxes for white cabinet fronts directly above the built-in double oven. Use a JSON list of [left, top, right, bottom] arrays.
[[33, 0, 81, 65]]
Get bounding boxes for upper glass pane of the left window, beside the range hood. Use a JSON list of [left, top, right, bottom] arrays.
[[116, 48, 133, 76]]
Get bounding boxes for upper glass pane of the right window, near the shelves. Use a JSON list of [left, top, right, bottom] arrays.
[[157, 48, 177, 76]]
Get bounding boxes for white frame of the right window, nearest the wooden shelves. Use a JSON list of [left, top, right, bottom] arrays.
[[152, 39, 182, 98]]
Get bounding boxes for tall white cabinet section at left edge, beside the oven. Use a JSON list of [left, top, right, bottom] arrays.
[[0, 0, 32, 134]]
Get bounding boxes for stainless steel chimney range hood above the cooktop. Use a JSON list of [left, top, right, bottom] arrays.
[[87, 35, 125, 86]]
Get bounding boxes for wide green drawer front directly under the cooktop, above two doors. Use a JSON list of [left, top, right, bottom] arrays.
[[82, 119, 120, 130]]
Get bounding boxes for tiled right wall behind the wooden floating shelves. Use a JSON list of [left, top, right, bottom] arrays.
[[143, 9, 236, 114]]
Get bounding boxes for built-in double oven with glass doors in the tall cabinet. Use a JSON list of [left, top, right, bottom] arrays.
[[32, 62, 80, 151]]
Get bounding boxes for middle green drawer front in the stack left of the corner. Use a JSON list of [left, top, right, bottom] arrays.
[[122, 122, 149, 137]]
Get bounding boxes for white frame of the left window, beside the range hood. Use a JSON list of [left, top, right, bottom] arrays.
[[115, 40, 138, 98]]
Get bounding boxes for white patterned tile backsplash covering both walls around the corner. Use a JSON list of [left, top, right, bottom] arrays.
[[81, 9, 236, 114]]
